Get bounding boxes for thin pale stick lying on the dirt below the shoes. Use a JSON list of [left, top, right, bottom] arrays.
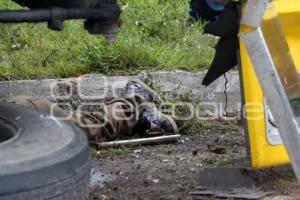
[[95, 135, 181, 147]]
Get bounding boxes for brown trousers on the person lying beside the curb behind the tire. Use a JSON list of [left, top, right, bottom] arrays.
[[2, 95, 156, 142]]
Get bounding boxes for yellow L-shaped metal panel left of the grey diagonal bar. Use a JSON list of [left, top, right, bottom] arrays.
[[241, 44, 288, 169]]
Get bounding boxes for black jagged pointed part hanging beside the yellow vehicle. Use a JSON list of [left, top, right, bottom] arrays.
[[190, 0, 240, 86]]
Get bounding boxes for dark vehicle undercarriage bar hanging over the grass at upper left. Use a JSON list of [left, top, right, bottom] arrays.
[[0, 0, 121, 42]]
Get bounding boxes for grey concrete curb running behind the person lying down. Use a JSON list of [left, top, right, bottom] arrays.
[[0, 71, 241, 112]]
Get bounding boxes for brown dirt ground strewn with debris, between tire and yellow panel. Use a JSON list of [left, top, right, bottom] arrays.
[[90, 122, 300, 200]]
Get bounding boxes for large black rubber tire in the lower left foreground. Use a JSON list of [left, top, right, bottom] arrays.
[[0, 103, 90, 200]]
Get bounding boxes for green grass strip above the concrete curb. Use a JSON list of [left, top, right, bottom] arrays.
[[0, 0, 215, 79]]
